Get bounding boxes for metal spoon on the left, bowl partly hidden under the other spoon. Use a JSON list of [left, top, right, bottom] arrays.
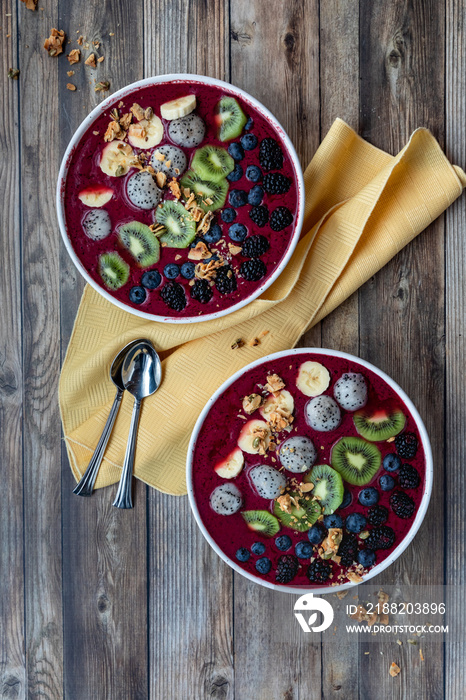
[[73, 338, 149, 496]]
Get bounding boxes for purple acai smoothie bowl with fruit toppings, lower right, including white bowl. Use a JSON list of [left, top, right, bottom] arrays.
[[187, 348, 432, 594]]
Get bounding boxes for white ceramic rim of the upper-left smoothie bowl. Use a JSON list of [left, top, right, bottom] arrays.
[[56, 73, 304, 323]]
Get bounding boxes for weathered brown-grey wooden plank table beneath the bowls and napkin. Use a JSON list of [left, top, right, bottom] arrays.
[[0, 0, 466, 700]]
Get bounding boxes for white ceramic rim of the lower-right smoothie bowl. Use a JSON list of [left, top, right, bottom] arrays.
[[186, 348, 433, 595]]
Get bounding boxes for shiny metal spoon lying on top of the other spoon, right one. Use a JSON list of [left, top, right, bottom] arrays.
[[113, 340, 162, 508]]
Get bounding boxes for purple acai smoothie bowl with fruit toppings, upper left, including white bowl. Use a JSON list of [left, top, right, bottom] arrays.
[[57, 74, 304, 323]]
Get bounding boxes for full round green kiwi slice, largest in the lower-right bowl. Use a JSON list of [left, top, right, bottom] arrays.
[[331, 437, 382, 486]]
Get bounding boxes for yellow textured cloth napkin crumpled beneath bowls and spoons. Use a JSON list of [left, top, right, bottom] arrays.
[[59, 119, 466, 495]]
